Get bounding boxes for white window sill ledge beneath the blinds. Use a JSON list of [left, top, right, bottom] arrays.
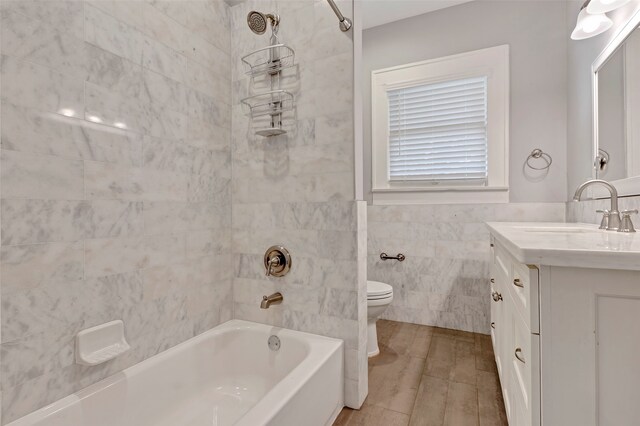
[[371, 186, 509, 205]]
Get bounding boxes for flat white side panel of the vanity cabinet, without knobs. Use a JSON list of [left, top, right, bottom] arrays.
[[540, 267, 640, 426]]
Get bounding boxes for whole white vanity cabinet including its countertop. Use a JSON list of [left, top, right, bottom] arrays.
[[489, 223, 640, 426]]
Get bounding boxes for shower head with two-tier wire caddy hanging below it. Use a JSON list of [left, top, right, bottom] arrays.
[[240, 11, 295, 137]]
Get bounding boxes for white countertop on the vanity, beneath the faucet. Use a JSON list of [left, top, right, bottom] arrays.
[[487, 222, 640, 270]]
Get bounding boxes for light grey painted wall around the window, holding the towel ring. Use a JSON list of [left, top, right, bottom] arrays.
[[363, 0, 569, 202]]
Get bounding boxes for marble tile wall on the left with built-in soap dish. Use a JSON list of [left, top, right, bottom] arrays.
[[0, 0, 232, 424]]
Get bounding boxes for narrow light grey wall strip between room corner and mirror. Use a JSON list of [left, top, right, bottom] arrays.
[[566, 0, 640, 195]]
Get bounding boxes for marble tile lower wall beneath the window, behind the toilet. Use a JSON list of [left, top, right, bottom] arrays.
[[367, 203, 565, 334]]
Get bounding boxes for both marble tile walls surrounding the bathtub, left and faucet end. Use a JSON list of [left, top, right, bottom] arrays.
[[0, 0, 367, 423]]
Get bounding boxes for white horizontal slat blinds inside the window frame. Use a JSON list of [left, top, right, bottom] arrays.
[[387, 77, 488, 184]]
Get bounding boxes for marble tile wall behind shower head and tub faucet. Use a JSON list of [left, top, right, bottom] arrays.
[[231, 0, 367, 408]]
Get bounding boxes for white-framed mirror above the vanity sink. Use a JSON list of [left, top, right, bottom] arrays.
[[592, 8, 640, 198]]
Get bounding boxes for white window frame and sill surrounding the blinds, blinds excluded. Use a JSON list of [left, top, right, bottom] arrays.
[[371, 45, 509, 204]]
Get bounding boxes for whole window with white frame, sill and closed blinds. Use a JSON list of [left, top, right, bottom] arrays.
[[372, 46, 509, 203]]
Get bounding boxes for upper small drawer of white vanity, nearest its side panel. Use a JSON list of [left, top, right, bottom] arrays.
[[507, 262, 540, 333]]
